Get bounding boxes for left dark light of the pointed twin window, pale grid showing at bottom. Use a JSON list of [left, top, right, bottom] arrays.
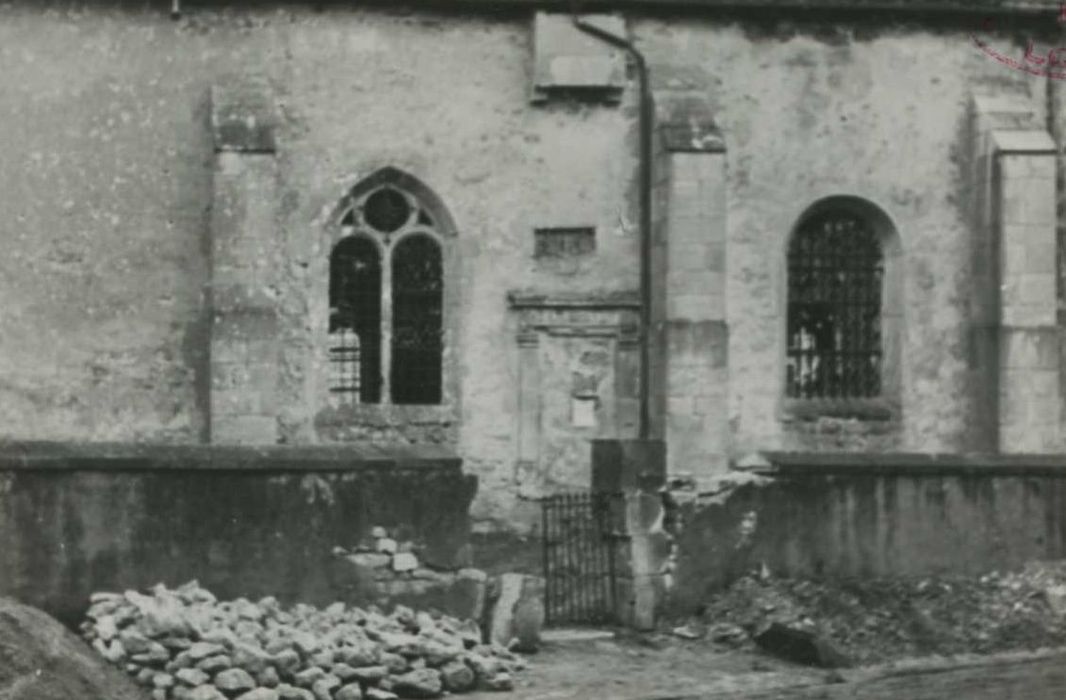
[[329, 237, 382, 404]]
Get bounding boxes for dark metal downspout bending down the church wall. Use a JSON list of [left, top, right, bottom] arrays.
[[570, 2, 655, 440]]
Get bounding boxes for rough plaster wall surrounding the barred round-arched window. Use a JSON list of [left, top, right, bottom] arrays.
[[635, 22, 1043, 454]]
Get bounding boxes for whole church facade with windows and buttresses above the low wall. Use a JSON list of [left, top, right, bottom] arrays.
[[0, 0, 1066, 527]]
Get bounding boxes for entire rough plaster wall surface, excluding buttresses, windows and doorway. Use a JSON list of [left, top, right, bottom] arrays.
[[0, 3, 1043, 530]]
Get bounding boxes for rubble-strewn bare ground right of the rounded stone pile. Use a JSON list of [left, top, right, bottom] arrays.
[[465, 561, 1066, 700]]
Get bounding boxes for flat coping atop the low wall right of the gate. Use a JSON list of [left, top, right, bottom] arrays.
[[734, 451, 1066, 478]]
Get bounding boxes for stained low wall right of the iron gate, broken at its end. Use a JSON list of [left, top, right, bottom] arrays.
[[668, 453, 1066, 612]]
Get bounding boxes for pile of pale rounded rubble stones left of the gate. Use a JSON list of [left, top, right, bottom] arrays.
[[81, 582, 526, 700]]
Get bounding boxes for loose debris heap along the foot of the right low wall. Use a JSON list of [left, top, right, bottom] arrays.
[[672, 560, 1066, 665]]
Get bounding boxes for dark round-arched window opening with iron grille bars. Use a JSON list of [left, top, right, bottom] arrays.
[[786, 211, 884, 398]]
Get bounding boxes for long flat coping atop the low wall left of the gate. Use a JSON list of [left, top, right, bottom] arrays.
[[0, 441, 463, 475]]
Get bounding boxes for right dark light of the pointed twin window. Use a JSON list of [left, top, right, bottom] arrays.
[[390, 234, 443, 404]]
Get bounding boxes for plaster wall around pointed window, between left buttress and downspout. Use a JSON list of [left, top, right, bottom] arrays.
[[270, 9, 636, 520]]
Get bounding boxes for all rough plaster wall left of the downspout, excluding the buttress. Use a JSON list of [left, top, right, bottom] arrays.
[[0, 3, 637, 518]]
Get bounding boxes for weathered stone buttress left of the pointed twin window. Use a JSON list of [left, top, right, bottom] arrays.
[[210, 79, 282, 444]]
